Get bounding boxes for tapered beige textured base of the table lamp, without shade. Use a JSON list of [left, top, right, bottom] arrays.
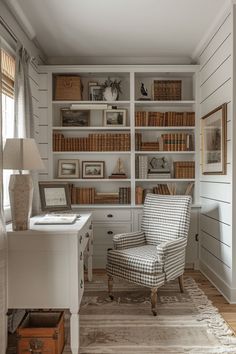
[[9, 174, 34, 231]]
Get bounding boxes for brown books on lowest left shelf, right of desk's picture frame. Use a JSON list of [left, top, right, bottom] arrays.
[[70, 184, 131, 204]]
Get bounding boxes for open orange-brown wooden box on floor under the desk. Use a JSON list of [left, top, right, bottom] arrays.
[[17, 311, 65, 354]]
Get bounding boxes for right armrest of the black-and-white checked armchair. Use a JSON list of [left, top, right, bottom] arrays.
[[156, 237, 187, 264]]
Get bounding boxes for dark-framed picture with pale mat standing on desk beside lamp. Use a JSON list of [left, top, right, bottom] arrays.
[[39, 182, 71, 211]]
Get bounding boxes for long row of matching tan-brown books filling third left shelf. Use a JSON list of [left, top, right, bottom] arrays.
[[53, 133, 130, 151]]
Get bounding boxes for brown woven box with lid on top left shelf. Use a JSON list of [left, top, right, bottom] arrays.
[[54, 75, 82, 101]]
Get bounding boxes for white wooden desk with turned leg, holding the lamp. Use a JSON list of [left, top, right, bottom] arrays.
[[7, 213, 93, 354]]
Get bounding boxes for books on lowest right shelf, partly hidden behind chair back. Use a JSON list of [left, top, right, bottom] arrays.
[[135, 183, 194, 204]]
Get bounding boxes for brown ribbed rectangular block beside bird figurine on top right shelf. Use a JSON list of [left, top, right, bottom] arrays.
[[153, 80, 181, 101]]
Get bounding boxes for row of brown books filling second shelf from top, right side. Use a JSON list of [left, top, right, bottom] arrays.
[[135, 111, 195, 127]]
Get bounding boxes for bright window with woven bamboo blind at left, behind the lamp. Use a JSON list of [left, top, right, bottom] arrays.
[[1, 49, 15, 210]]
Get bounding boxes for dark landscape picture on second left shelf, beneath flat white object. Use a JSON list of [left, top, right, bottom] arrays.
[[61, 108, 90, 127]]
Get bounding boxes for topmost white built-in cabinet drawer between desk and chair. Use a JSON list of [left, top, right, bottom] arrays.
[[93, 209, 131, 222]]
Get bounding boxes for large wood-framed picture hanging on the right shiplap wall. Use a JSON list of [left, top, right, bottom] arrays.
[[201, 103, 227, 174]]
